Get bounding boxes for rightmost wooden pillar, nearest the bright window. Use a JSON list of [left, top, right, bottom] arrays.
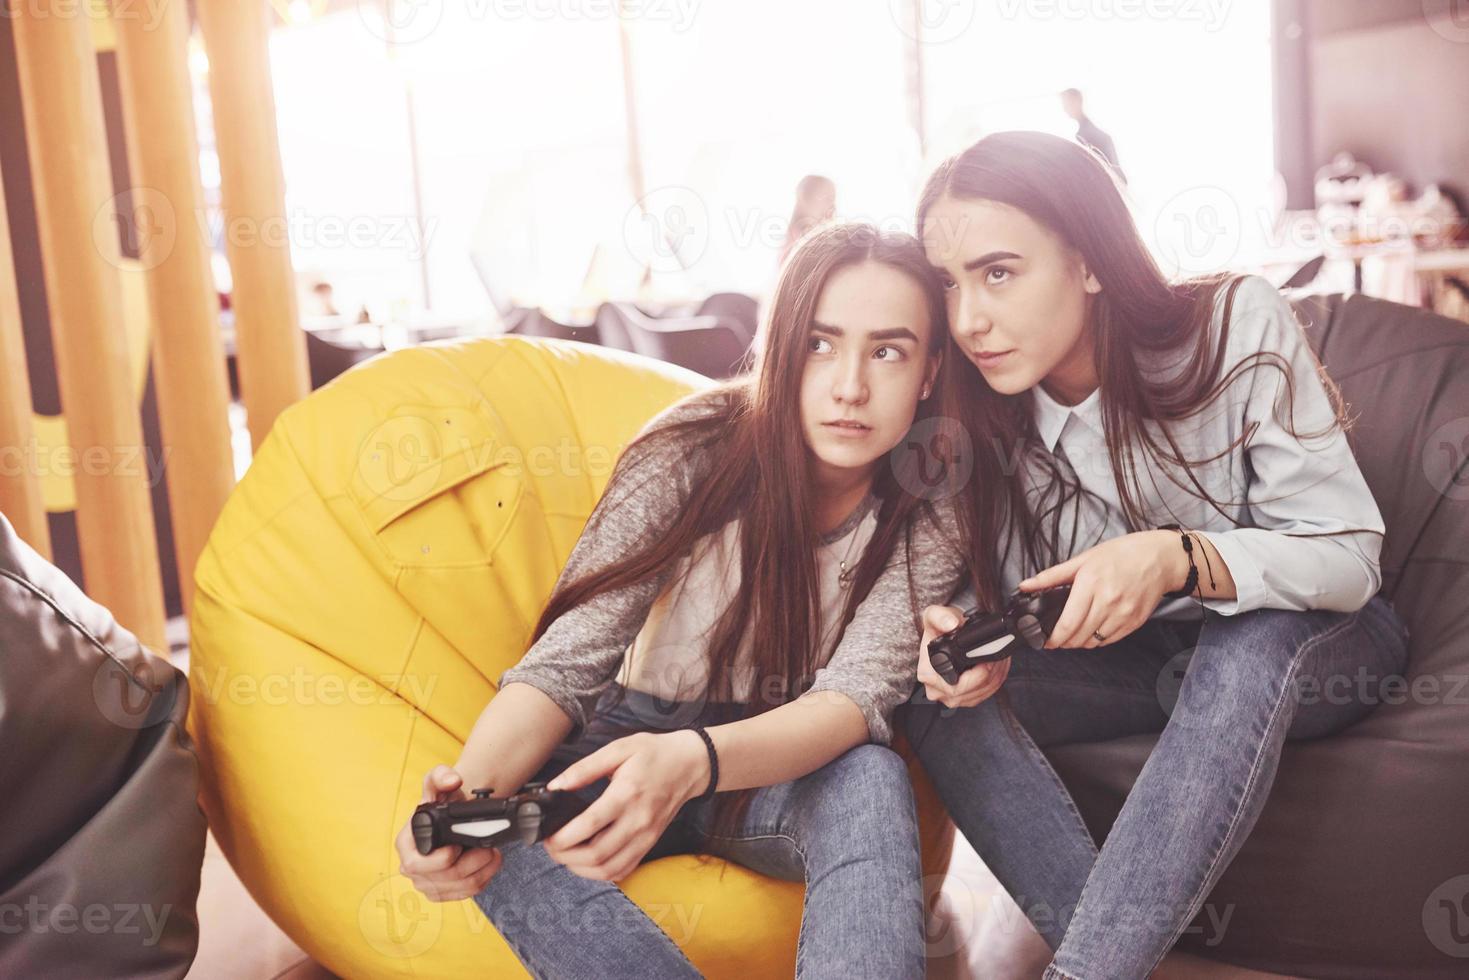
[[198, 0, 311, 447]]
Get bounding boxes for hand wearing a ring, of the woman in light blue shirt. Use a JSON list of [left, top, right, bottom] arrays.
[[1019, 530, 1188, 649]]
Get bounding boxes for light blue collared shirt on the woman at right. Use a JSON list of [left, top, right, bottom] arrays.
[[1002, 276, 1384, 619]]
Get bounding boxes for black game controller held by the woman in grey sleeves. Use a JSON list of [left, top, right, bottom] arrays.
[[411, 783, 586, 854]]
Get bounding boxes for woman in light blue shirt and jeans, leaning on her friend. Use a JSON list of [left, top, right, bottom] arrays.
[[905, 132, 1407, 980]]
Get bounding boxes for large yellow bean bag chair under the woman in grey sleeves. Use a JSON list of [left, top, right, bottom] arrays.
[[190, 338, 952, 977]]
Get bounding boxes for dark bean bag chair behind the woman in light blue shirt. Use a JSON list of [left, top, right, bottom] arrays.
[[1052, 297, 1469, 980]]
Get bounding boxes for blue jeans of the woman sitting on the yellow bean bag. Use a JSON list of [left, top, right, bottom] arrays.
[[474, 688, 924, 980]]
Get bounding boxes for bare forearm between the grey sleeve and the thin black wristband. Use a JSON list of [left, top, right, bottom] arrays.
[[701, 691, 868, 792]]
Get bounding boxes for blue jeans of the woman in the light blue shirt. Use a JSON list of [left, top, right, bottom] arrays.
[[899, 598, 1407, 980]]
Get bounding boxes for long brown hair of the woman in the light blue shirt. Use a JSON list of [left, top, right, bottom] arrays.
[[917, 132, 1347, 608]]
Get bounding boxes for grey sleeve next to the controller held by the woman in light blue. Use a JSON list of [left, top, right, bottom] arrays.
[[811, 502, 965, 745]]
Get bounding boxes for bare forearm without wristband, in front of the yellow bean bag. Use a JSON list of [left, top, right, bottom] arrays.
[[454, 683, 571, 796]]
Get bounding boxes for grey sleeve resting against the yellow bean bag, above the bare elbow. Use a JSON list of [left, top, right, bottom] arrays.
[[499, 395, 711, 741]]
